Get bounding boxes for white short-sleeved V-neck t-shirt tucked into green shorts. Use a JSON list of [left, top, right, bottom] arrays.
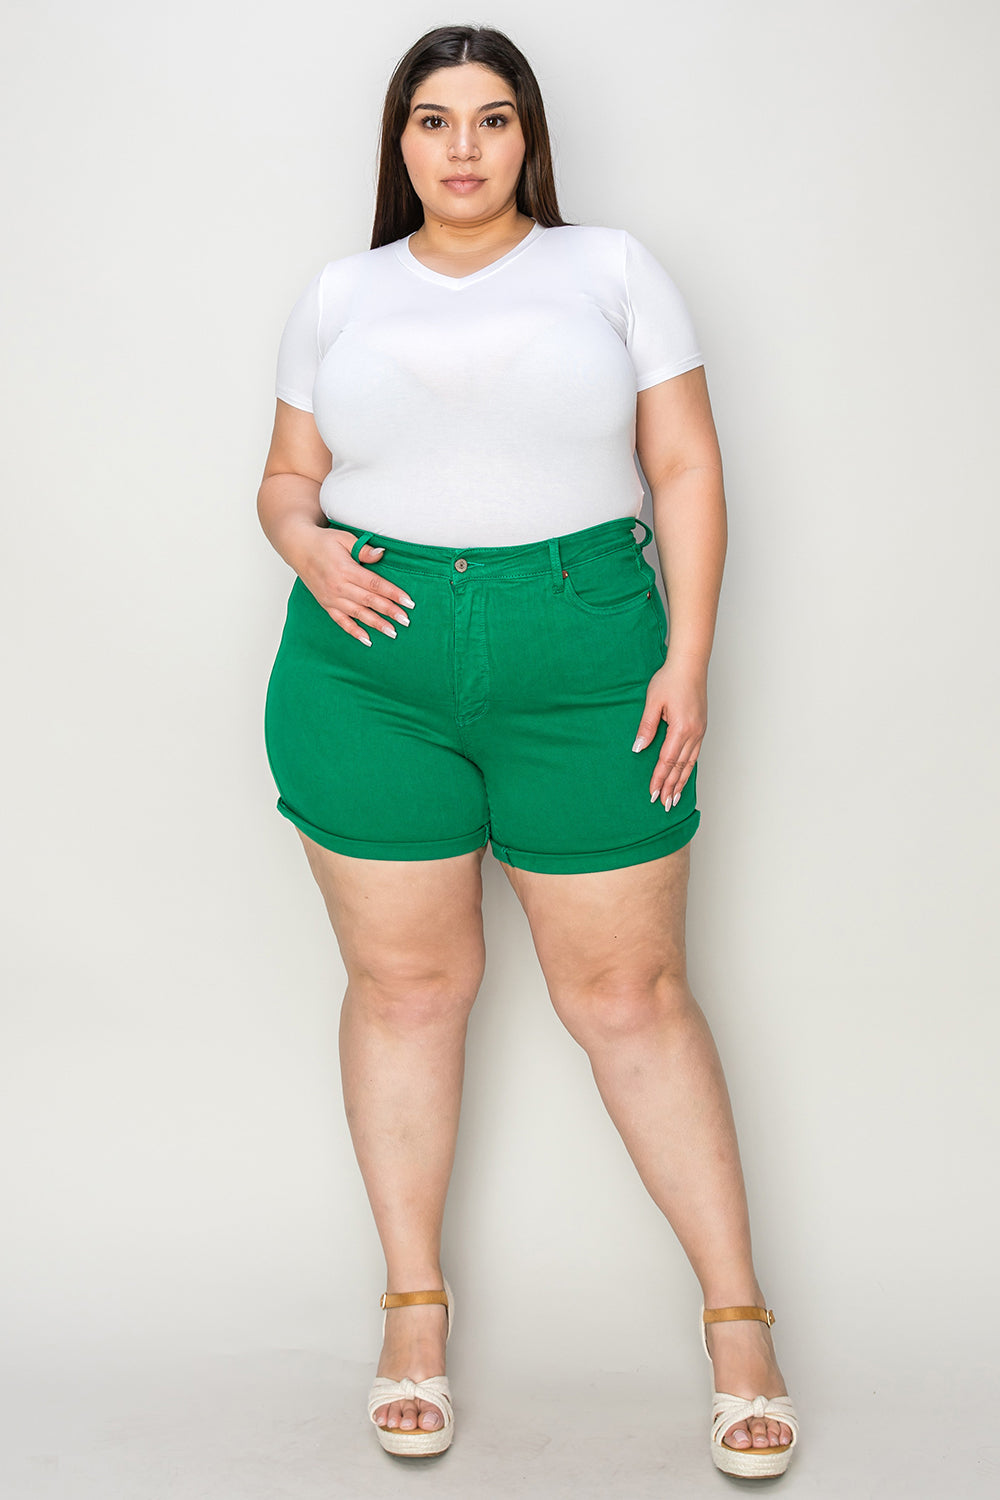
[[276, 224, 705, 546]]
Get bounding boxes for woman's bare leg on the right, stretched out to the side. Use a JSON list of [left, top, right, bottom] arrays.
[[504, 846, 792, 1448]]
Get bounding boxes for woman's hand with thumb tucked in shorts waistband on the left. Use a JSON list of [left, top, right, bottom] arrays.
[[294, 527, 414, 647]]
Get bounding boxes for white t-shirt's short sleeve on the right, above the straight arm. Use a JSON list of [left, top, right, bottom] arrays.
[[625, 231, 705, 390]]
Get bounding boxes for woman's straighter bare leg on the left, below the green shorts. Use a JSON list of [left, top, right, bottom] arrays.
[[301, 834, 486, 1428]]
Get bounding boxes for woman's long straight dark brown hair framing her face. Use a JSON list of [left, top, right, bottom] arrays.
[[372, 26, 565, 251]]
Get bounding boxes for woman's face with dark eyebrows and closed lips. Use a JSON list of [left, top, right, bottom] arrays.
[[399, 63, 525, 225]]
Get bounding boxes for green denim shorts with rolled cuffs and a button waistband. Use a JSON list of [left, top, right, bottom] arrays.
[[264, 516, 700, 875]]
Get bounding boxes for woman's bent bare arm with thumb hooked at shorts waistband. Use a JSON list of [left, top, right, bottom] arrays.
[[256, 399, 412, 647]]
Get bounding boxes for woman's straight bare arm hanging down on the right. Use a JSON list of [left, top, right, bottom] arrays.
[[633, 365, 727, 807]]
